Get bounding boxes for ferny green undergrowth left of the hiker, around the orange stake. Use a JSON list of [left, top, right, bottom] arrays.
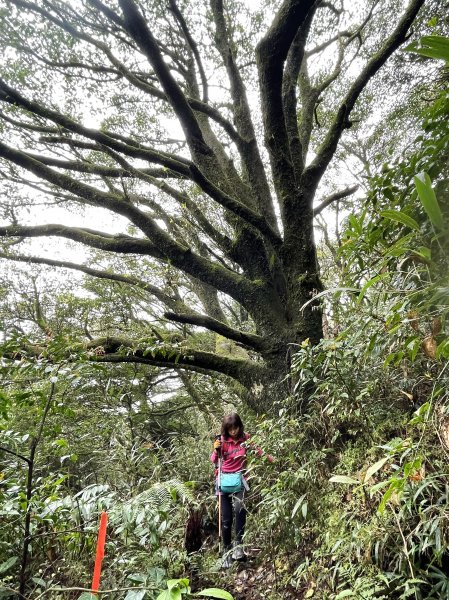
[[0, 341, 203, 600]]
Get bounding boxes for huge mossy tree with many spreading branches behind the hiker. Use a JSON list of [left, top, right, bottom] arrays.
[[0, 0, 424, 408]]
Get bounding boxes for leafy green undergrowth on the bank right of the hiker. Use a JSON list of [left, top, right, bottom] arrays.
[[260, 332, 449, 599]]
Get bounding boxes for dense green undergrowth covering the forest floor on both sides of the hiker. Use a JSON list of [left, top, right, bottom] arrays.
[[0, 324, 449, 600]]
